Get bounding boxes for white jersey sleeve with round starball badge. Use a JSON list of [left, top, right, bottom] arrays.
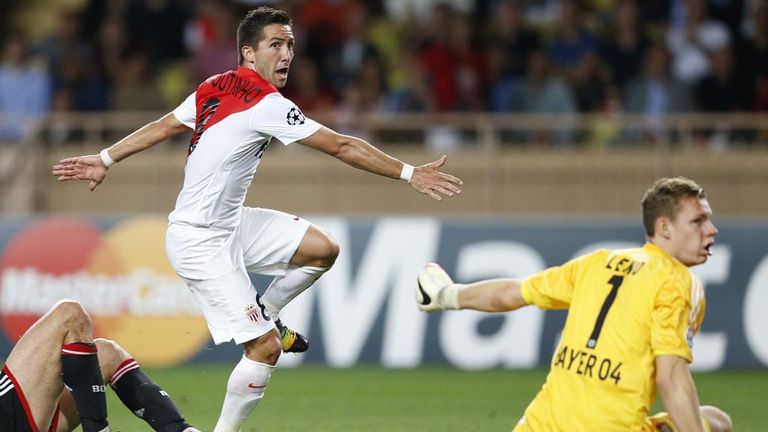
[[249, 93, 322, 145]]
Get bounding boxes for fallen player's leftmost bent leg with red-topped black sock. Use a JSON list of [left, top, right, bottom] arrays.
[[6, 300, 108, 432]]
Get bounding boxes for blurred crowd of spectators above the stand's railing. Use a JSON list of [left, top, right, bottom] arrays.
[[0, 0, 768, 145]]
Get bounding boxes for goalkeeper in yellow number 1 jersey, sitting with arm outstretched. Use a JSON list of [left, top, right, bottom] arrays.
[[417, 177, 732, 432]]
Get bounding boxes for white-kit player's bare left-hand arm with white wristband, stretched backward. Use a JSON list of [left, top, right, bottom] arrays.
[[51, 113, 189, 190]]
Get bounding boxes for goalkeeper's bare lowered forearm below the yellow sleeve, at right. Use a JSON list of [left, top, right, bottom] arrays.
[[656, 355, 706, 432]]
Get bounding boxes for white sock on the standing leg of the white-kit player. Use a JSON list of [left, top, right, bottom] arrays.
[[213, 356, 275, 432]]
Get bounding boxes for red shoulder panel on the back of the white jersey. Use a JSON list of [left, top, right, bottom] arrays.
[[190, 66, 277, 153]]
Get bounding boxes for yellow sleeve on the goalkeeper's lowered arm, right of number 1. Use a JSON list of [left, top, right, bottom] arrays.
[[651, 277, 703, 362]]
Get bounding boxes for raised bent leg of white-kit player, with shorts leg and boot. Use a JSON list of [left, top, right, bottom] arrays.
[[239, 208, 339, 352]]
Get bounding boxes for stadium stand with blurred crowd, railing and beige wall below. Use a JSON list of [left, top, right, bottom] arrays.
[[0, 0, 768, 215]]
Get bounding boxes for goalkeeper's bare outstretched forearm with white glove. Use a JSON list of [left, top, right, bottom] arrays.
[[416, 263, 528, 312]]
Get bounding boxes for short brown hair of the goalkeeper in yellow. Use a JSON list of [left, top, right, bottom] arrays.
[[642, 177, 706, 237]]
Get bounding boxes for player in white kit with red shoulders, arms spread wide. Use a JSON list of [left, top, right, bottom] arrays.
[[53, 7, 462, 432]]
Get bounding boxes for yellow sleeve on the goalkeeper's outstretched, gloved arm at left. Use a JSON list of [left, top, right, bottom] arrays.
[[520, 254, 592, 309]]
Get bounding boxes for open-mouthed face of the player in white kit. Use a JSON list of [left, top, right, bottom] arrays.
[[253, 24, 294, 88]]
